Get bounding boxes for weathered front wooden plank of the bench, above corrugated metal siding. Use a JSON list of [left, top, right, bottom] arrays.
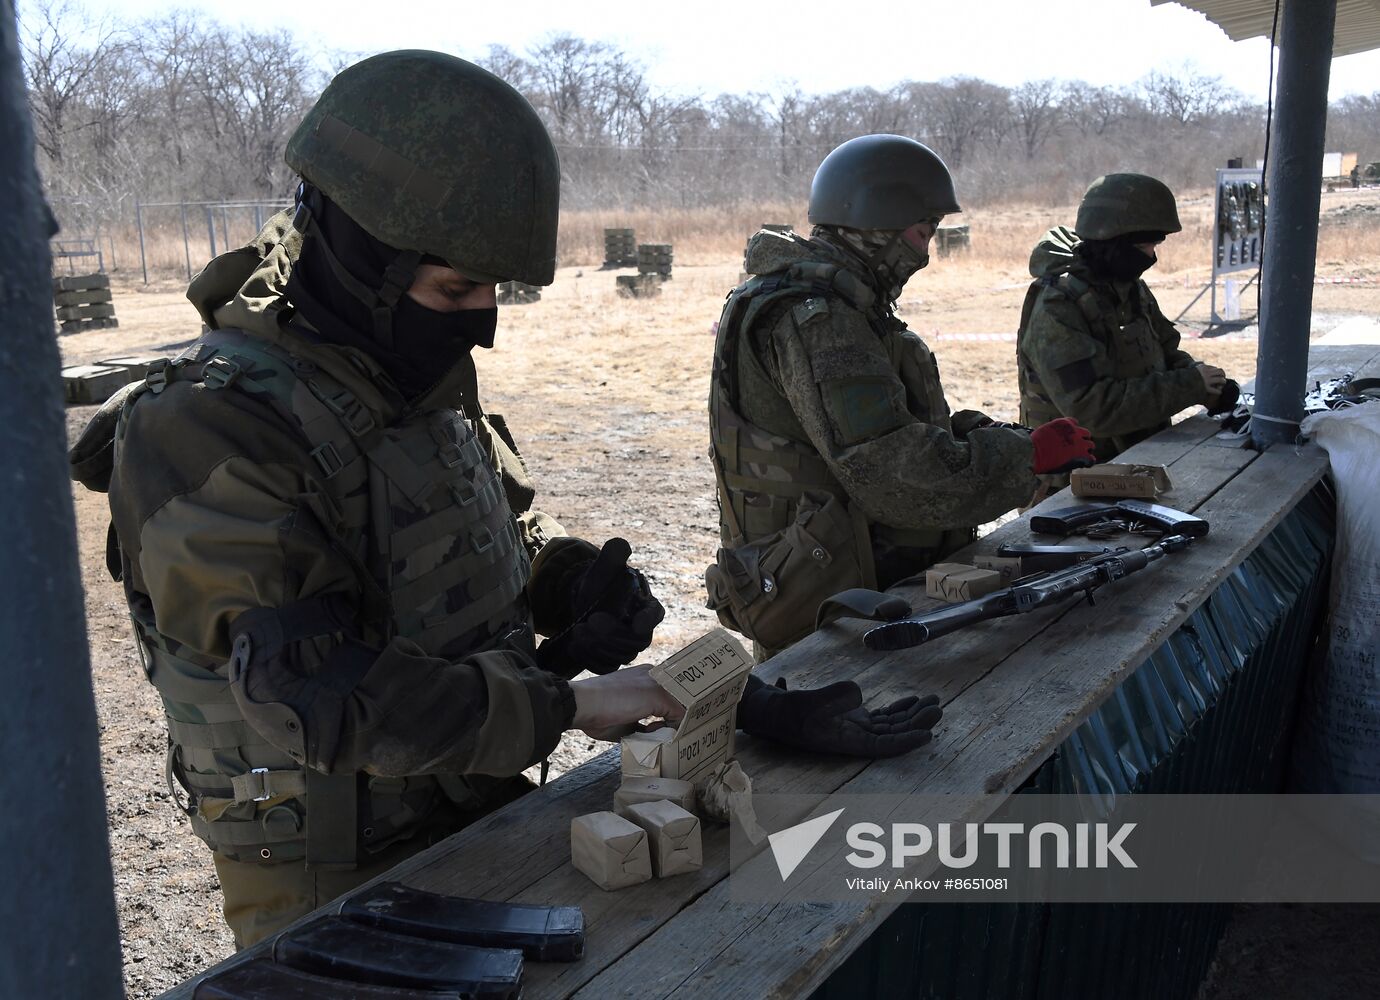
[[580, 447, 1326, 1000]]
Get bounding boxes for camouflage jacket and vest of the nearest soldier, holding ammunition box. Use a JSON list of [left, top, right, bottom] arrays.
[[79, 214, 574, 866]]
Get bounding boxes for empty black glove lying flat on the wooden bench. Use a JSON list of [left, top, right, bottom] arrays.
[[738, 677, 944, 757]]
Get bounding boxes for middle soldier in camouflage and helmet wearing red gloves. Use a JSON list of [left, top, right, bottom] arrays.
[[705, 135, 1092, 657]]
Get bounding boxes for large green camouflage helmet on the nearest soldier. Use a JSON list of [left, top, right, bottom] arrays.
[[286, 50, 560, 284]]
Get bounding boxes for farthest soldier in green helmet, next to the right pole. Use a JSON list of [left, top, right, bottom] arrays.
[[1016, 174, 1239, 488]]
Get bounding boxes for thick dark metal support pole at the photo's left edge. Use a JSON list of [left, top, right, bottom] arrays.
[[0, 0, 124, 1000]]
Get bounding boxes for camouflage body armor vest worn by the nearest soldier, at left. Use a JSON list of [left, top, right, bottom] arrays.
[[117, 330, 533, 866]]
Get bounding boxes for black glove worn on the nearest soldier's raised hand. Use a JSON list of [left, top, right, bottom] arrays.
[[533, 538, 667, 677]]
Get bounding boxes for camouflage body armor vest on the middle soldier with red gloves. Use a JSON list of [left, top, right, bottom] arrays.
[[707, 253, 972, 654]]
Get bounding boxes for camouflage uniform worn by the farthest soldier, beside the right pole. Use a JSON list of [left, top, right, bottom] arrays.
[[1016, 228, 1212, 463]]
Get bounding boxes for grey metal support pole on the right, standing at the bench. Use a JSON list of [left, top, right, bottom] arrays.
[[1250, 0, 1337, 448]]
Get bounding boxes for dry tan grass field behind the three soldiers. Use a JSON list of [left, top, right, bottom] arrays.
[[61, 192, 1380, 997]]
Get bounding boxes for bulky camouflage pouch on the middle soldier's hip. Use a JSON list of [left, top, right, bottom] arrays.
[[704, 491, 872, 650]]
